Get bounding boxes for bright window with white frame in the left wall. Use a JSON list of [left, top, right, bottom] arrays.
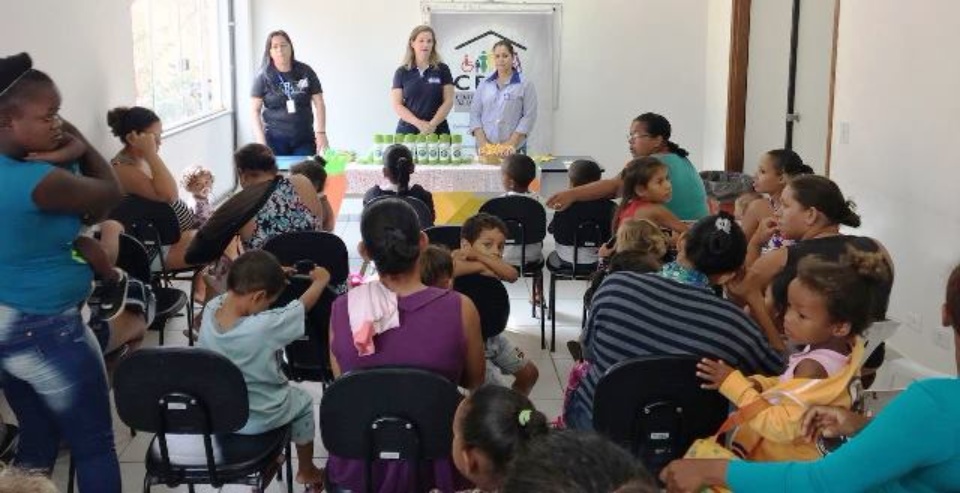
[[131, 0, 227, 129]]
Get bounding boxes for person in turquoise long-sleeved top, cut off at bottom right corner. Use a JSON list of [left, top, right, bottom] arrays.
[[660, 266, 960, 493]]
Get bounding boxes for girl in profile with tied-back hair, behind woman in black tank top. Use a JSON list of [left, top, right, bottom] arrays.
[[741, 149, 813, 267]]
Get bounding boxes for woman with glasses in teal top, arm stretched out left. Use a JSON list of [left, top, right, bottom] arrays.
[[547, 113, 709, 221]]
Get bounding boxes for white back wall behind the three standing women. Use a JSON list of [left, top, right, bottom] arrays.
[[248, 0, 707, 174]]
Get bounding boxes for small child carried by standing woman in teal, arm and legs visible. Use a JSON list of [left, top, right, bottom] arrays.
[[27, 129, 128, 320]]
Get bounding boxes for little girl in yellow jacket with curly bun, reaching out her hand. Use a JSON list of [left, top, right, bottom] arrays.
[[697, 248, 890, 461]]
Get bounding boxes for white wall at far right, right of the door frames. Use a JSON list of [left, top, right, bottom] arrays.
[[831, 0, 960, 374]]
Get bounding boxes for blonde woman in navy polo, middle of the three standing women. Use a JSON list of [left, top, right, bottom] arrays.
[[390, 26, 453, 134]]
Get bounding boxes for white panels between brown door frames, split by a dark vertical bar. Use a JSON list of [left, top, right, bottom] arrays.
[[744, 0, 834, 173]]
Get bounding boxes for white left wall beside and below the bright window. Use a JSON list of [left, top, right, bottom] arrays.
[[0, 0, 234, 198]]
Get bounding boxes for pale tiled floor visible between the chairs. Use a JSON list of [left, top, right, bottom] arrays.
[[47, 198, 585, 493]]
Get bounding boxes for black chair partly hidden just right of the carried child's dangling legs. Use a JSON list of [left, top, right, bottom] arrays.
[[117, 233, 188, 346]]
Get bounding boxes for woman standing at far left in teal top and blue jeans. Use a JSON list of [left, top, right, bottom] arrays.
[[0, 53, 121, 493]]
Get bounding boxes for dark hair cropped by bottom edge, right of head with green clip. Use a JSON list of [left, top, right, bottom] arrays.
[[501, 430, 657, 493]]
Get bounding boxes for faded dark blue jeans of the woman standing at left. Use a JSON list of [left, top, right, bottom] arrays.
[[0, 305, 120, 493]]
